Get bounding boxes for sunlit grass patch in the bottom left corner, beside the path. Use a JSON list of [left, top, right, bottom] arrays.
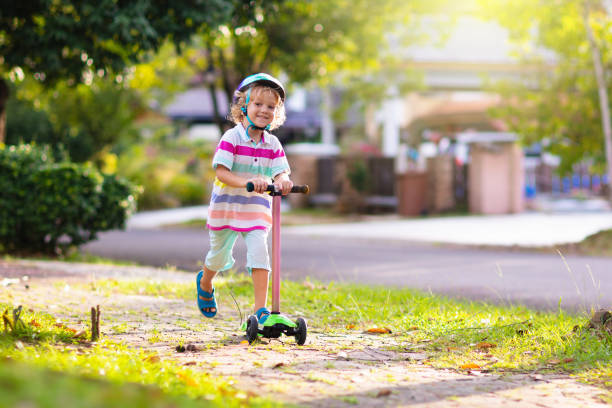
[[0, 304, 278, 408]]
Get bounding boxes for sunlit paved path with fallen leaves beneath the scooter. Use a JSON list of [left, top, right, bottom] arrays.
[[0, 261, 610, 408]]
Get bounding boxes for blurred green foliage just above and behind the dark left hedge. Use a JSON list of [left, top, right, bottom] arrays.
[[6, 77, 143, 163]]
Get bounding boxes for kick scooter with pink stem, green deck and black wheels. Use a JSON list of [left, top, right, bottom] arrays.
[[241, 182, 309, 346]]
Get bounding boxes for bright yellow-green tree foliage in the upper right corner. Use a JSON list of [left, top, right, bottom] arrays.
[[481, 0, 612, 200]]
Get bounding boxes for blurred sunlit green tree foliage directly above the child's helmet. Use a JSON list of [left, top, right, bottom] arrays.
[[200, 0, 441, 132]]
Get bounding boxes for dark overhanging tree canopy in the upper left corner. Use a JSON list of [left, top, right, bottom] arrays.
[[0, 0, 232, 141]]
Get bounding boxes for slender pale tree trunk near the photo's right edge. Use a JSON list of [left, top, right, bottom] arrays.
[[583, 0, 612, 201]]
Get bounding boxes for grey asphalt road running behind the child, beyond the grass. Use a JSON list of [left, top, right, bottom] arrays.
[[83, 229, 612, 311]]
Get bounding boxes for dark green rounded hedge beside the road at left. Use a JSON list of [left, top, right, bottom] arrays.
[[0, 145, 136, 254]]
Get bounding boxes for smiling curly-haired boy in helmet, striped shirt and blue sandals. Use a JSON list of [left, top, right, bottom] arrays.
[[196, 73, 293, 324]]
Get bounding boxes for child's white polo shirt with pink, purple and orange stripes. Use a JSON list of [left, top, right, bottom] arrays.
[[207, 124, 289, 231]]
